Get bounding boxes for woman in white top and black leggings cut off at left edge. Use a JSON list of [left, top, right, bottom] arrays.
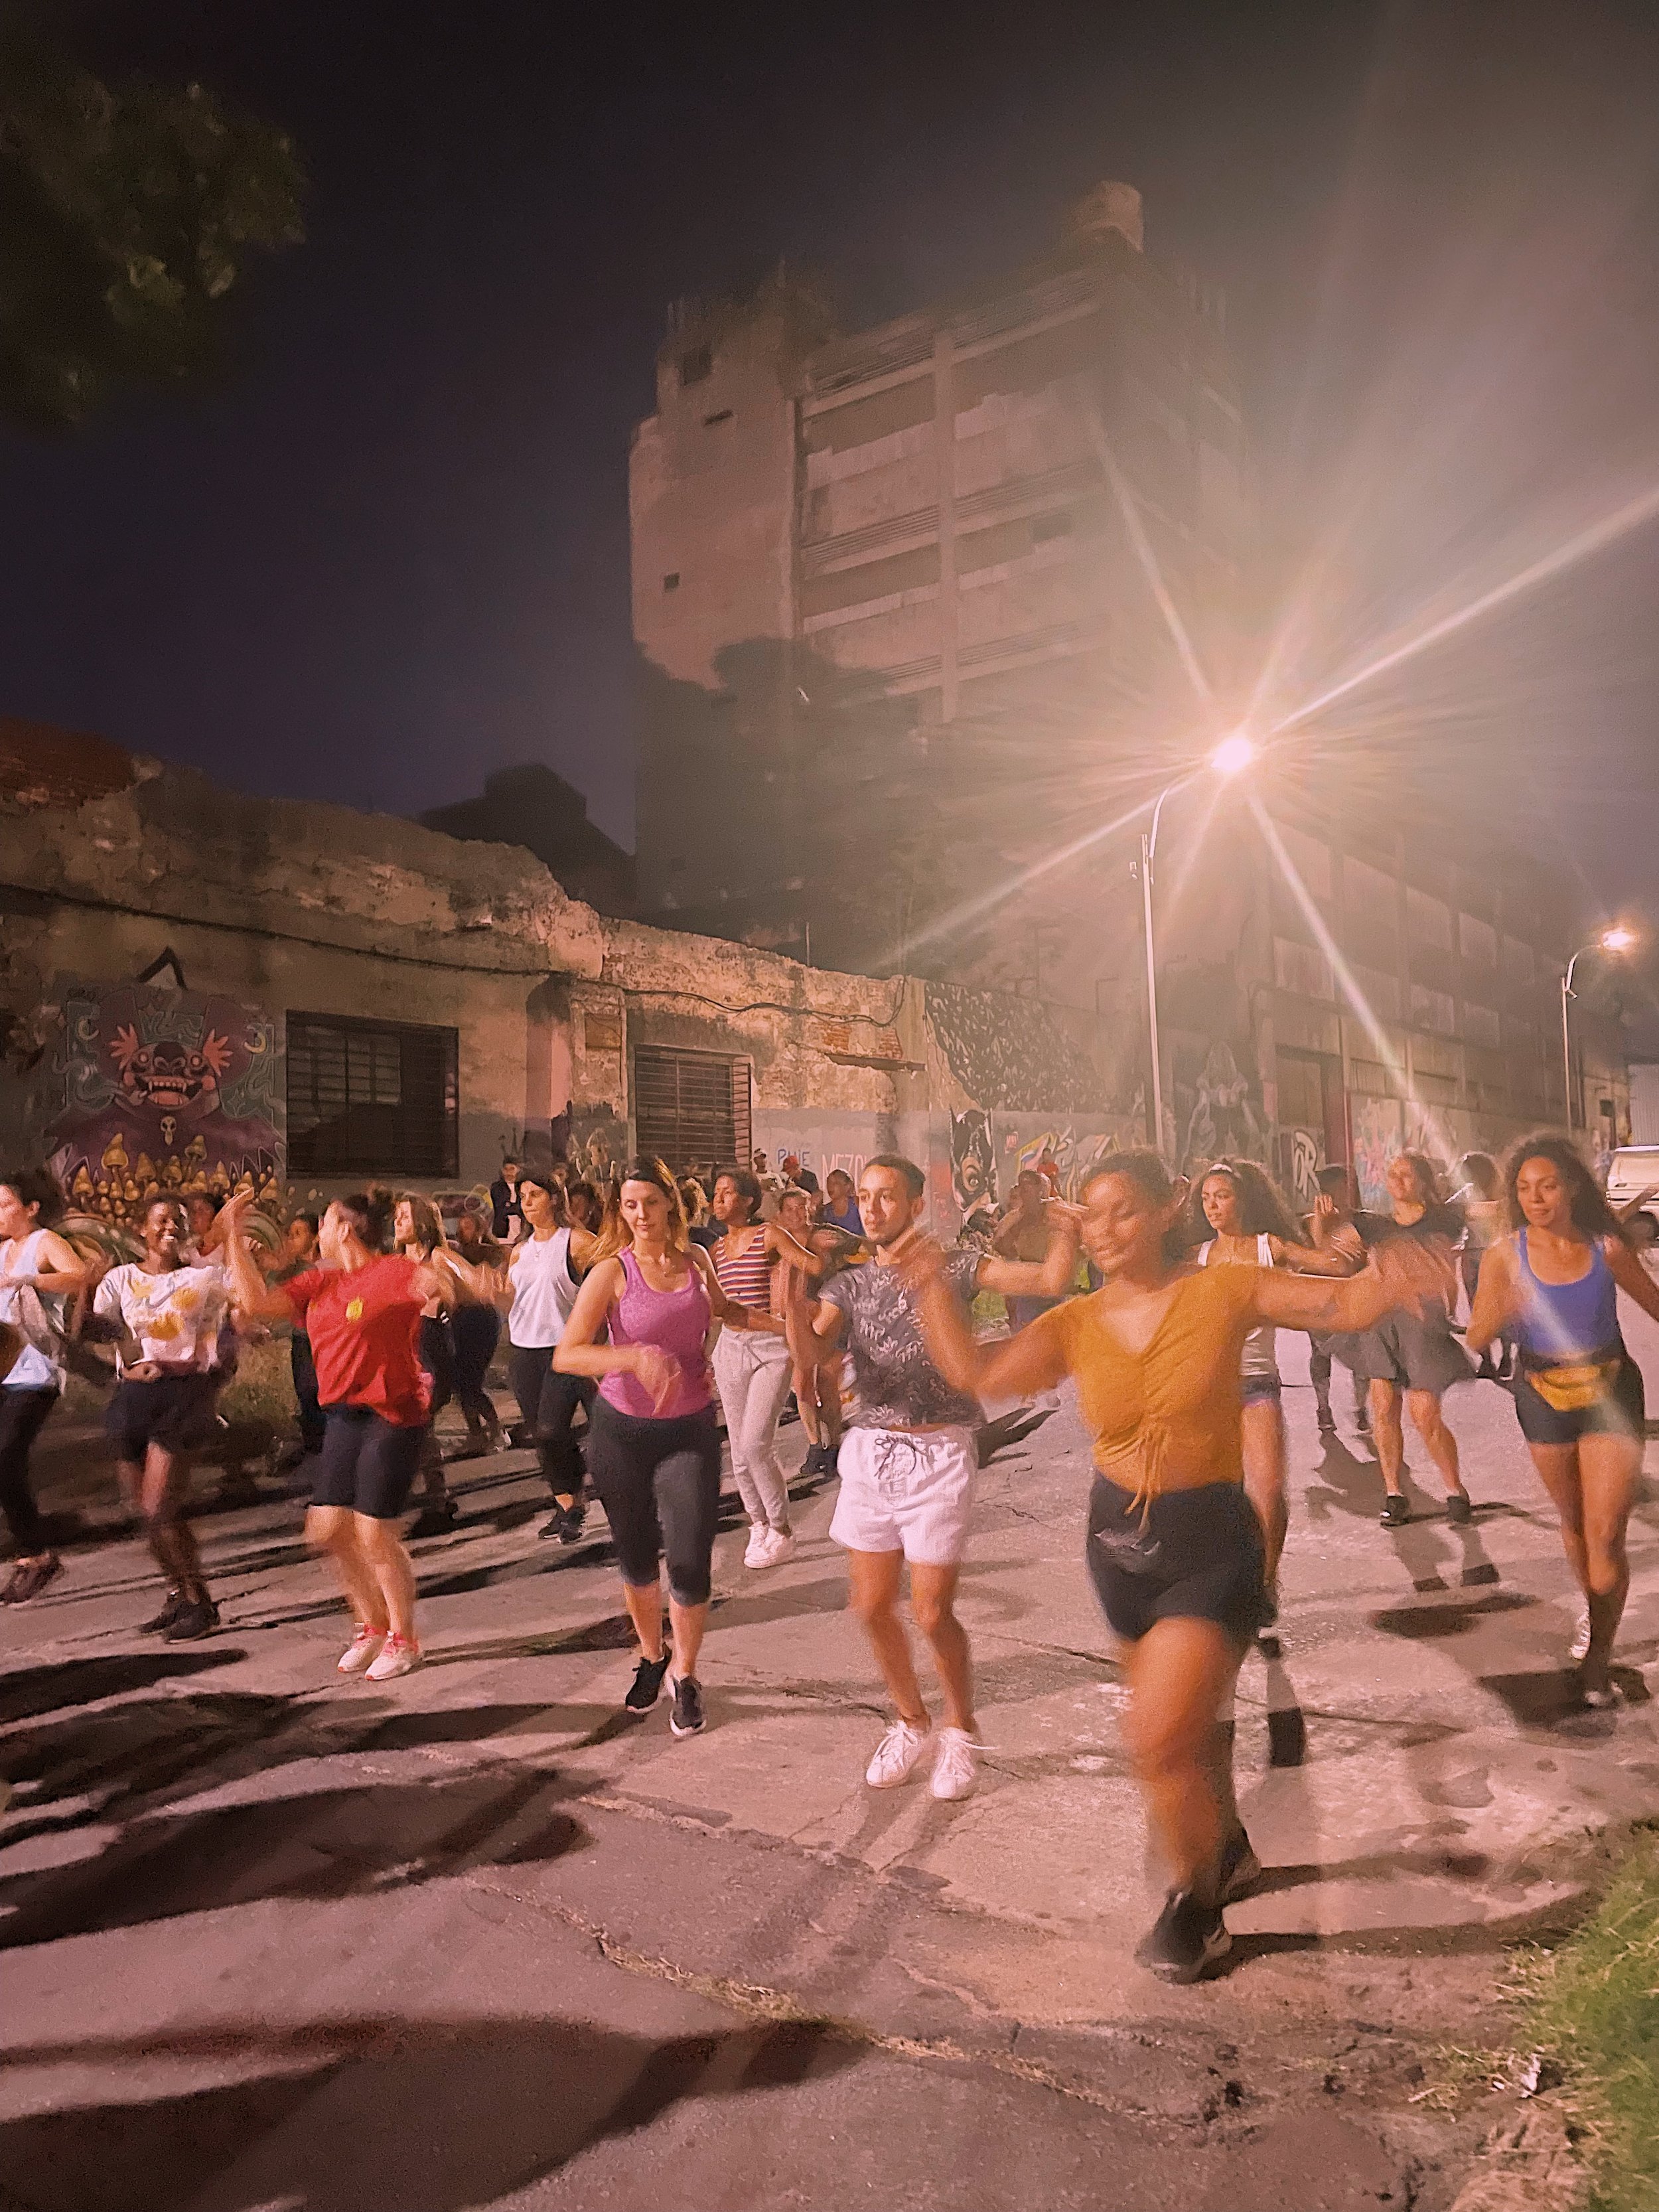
[[0, 1168, 86, 1606]]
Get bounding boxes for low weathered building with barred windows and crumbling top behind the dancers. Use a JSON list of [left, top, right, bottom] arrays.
[[0, 725, 1135, 1232]]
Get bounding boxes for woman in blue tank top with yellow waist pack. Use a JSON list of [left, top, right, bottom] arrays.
[[1469, 1137, 1659, 1706]]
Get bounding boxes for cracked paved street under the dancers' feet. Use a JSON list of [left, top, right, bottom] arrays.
[[0, 1300, 1659, 2212]]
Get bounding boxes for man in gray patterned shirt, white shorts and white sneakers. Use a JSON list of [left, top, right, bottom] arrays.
[[792, 1152, 1077, 1799]]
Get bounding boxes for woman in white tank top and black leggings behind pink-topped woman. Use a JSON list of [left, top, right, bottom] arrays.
[[502, 1168, 597, 1544]]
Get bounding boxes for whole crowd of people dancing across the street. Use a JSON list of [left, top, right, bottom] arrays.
[[0, 1135, 1659, 1982]]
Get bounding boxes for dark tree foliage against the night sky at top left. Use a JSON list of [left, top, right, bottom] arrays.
[[0, 42, 305, 433]]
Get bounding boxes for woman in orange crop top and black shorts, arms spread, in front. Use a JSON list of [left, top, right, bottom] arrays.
[[916, 1152, 1445, 1982]]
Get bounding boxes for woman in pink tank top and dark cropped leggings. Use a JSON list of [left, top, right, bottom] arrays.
[[553, 1159, 765, 1736]]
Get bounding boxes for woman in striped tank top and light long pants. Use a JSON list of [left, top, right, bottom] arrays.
[[710, 1168, 823, 1568]]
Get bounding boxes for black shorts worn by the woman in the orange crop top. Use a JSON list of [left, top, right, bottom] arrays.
[[1088, 1475, 1267, 1643]]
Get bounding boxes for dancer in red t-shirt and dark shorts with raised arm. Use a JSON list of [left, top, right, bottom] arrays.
[[221, 1197, 443, 1681]]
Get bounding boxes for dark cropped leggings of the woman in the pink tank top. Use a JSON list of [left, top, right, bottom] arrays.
[[589, 1398, 721, 1606]]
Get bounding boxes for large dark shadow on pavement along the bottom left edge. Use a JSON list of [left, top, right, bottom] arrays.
[[0, 2018, 861, 2212]]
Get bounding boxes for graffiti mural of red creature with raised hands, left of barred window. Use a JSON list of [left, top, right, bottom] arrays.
[[46, 984, 279, 1221]]
